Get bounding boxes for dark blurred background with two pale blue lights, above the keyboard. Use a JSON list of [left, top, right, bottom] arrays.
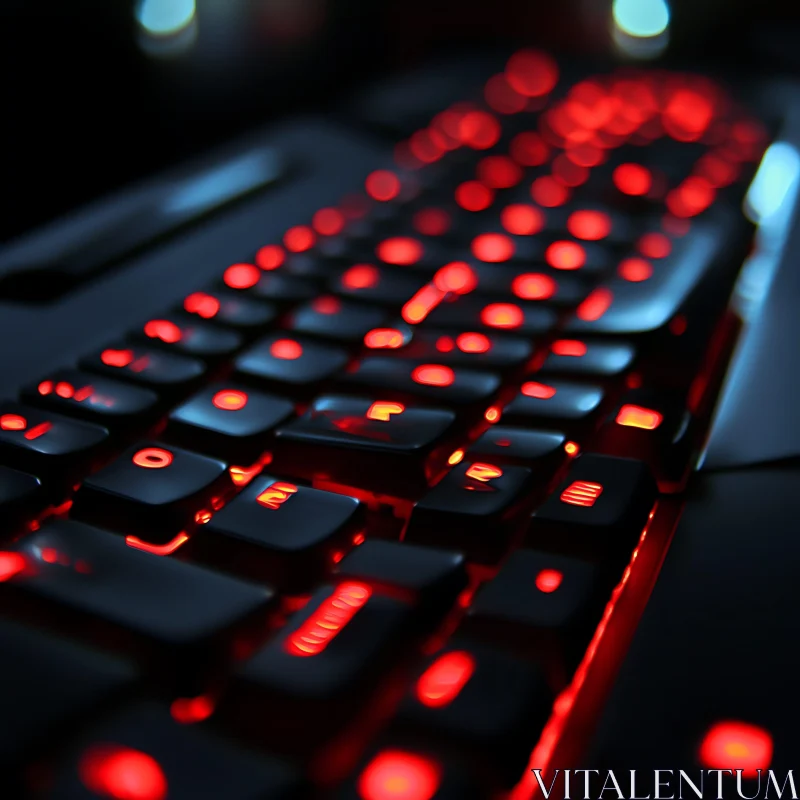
[[0, 0, 800, 243]]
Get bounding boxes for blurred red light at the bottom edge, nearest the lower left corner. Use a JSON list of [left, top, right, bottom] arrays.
[[78, 744, 167, 800]]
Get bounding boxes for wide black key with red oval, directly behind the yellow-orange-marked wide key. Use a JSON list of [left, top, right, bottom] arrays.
[[337, 356, 500, 407]]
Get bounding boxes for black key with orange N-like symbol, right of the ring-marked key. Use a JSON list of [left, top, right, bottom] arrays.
[[194, 475, 364, 592]]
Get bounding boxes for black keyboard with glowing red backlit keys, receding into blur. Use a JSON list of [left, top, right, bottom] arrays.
[[0, 50, 771, 800]]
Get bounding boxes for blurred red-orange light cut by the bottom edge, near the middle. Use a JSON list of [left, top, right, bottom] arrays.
[[358, 750, 441, 800]]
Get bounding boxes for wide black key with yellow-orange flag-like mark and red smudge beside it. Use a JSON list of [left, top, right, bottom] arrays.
[[274, 395, 456, 497]]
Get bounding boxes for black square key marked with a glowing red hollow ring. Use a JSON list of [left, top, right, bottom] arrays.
[[72, 442, 233, 544]]
